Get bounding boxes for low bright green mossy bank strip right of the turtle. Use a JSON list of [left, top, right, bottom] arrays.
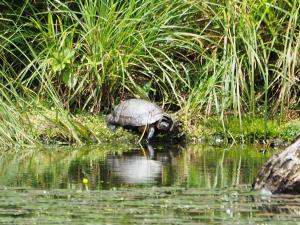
[[189, 116, 300, 144]]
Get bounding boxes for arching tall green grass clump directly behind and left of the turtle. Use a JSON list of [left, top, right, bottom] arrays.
[[11, 0, 196, 112]]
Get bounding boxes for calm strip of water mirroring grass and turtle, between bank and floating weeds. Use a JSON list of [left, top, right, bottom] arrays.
[[0, 145, 268, 189]]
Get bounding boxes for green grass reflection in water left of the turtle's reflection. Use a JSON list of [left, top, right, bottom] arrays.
[[0, 145, 129, 189]]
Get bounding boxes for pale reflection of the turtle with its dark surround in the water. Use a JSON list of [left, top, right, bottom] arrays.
[[105, 145, 182, 186]]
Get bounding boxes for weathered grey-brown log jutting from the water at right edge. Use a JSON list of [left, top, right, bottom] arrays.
[[253, 135, 300, 194]]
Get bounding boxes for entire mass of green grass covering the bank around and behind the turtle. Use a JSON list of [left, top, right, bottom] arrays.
[[0, 0, 300, 145]]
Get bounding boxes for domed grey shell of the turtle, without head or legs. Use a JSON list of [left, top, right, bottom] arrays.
[[110, 99, 164, 127]]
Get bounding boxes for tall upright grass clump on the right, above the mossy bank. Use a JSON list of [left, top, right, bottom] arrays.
[[188, 1, 300, 125]]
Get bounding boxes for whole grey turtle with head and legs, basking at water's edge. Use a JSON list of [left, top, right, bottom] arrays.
[[106, 99, 174, 142]]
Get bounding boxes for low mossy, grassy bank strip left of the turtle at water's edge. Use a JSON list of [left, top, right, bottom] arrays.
[[27, 109, 138, 145]]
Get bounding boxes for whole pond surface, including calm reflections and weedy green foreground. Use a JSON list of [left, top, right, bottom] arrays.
[[0, 144, 300, 224]]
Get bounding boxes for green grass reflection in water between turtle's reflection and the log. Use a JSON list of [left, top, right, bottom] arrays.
[[164, 145, 269, 189]]
